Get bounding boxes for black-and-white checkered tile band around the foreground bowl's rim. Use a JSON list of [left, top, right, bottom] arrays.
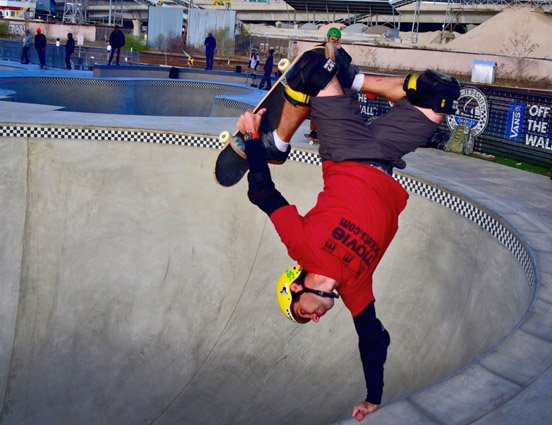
[[0, 124, 536, 289]]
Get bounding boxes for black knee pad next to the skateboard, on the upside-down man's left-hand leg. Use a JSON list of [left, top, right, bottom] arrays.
[[286, 50, 337, 96]]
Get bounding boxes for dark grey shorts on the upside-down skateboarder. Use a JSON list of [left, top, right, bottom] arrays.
[[311, 90, 438, 168]]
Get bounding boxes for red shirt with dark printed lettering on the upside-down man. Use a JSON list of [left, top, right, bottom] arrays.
[[270, 161, 408, 317]]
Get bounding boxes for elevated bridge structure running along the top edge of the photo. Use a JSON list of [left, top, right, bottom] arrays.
[[72, 0, 552, 39]]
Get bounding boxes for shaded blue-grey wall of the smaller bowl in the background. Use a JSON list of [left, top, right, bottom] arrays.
[[0, 77, 251, 117]]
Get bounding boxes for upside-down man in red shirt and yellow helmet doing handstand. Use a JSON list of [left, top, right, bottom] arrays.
[[237, 52, 460, 421]]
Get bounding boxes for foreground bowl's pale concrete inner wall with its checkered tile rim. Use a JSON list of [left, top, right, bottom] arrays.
[[0, 124, 535, 425]]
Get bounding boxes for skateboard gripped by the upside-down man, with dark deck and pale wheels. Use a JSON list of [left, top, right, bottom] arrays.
[[214, 46, 330, 187]]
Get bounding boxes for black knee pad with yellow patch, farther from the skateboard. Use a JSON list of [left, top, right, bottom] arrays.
[[403, 69, 460, 114]]
